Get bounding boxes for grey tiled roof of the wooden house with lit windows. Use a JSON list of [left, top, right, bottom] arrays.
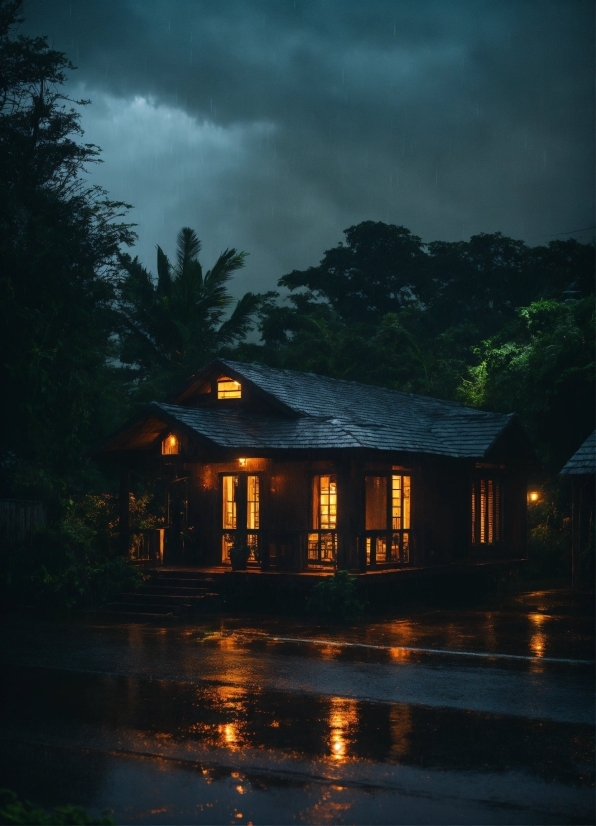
[[152, 360, 514, 458]]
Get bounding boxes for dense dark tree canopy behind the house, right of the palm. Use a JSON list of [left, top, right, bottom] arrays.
[[237, 221, 594, 472]]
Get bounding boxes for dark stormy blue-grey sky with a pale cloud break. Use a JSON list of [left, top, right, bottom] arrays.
[[24, 0, 594, 292]]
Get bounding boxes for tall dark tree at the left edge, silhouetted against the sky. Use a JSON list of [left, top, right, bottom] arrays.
[[0, 0, 134, 495]]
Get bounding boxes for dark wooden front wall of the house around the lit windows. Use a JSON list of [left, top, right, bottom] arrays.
[[163, 448, 526, 571]]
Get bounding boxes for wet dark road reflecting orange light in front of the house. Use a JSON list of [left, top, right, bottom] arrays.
[[0, 592, 594, 824]]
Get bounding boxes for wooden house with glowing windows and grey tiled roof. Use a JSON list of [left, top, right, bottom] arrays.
[[96, 360, 532, 573]]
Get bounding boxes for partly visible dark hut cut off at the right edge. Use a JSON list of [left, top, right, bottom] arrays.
[[561, 430, 596, 590]]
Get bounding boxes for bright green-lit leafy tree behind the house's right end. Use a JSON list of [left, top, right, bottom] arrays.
[[458, 296, 595, 466]]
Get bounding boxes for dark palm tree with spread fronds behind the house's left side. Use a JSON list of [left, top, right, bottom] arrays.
[[118, 227, 263, 390]]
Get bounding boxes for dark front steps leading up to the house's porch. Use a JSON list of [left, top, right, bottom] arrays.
[[104, 568, 220, 620]]
